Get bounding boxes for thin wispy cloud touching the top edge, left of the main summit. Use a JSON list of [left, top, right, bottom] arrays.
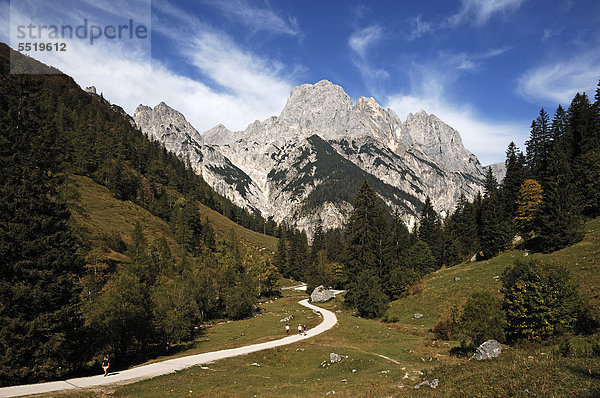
[[206, 0, 302, 36]]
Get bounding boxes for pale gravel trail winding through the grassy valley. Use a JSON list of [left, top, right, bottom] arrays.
[[0, 299, 337, 397]]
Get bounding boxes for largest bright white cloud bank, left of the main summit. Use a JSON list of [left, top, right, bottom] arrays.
[[8, 3, 293, 132]]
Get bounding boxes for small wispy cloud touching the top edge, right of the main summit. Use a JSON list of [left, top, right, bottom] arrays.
[[446, 0, 525, 26]]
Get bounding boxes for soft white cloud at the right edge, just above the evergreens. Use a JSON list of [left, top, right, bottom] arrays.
[[516, 50, 600, 104]]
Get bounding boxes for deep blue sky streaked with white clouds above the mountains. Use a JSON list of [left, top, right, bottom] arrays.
[[0, 0, 600, 164]]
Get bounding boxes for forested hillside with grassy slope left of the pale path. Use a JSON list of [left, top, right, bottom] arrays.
[[0, 44, 279, 385]]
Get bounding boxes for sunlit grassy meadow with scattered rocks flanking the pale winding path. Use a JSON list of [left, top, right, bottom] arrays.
[[50, 219, 600, 397]]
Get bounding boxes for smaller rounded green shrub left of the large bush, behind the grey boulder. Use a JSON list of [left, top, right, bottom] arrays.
[[458, 292, 506, 347]]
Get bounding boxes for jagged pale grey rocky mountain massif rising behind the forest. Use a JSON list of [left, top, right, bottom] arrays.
[[134, 81, 484, 235]]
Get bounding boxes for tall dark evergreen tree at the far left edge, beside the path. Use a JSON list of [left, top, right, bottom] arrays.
[[0, 76, 84, 385]]
